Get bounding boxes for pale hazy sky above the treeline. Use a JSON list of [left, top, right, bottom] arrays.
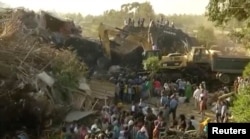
[[0, 0, 209, 15]]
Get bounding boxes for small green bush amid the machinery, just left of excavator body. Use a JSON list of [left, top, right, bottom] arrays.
[[143, 57, 160, 72]]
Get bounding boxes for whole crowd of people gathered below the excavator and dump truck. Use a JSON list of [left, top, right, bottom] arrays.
[[58, 73, 221, 139]]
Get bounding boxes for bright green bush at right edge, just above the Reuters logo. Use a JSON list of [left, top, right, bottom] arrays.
[[232, 86, 250, 123]]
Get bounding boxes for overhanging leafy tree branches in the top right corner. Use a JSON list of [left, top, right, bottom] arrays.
[[206, 0, 250, 42]]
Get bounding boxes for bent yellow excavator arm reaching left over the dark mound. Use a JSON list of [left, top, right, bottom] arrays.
[[98, 23, 160, 68]]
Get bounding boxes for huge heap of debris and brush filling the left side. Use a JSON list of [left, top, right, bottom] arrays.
[[0, 9, 104, 138]]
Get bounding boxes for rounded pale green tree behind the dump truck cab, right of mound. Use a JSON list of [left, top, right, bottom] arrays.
[[197, 26, 216, 46]]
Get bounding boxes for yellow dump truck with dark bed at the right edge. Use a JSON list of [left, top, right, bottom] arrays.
[[185, 47, 250, 84]]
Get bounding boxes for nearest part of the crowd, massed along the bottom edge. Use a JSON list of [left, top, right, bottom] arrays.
[[59, 98, 199, 139]]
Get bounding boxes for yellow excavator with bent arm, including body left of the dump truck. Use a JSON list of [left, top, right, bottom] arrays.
[[98, 23, 188, 70]]
